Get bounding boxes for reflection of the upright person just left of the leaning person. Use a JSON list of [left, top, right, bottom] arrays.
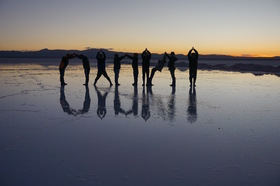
[[141, 86, 153, 121]]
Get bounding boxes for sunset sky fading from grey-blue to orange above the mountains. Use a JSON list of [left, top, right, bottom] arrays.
[[0, 0, 280, 56]]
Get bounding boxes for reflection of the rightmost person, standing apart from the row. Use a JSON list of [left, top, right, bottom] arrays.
[[188, 87, 197, 123]]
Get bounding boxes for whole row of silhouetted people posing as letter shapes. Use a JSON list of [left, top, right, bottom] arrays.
[[59, 47, 199, 87]]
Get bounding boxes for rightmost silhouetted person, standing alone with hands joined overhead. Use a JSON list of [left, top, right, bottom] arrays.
[[188, 47, 198, 87]]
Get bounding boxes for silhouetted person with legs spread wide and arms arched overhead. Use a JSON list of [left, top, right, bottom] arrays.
[[94, 50, 113, 86]]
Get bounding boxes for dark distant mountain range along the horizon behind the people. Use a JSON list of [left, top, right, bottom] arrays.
[[0, 48, 280, 60]]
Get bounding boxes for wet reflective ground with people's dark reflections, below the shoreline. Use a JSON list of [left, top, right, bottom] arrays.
[[0, 64, 280, 185]]
